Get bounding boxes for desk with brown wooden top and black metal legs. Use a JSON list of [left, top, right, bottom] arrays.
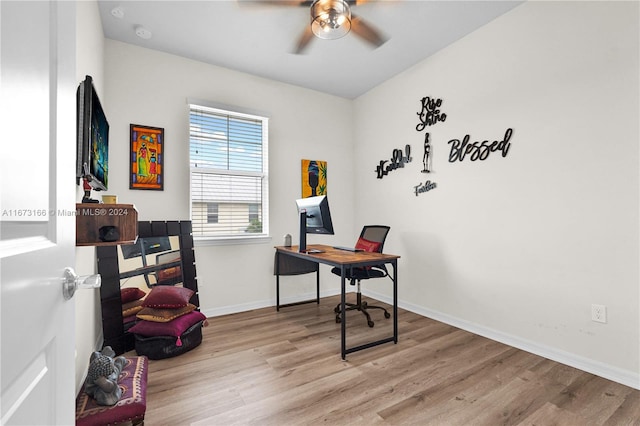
[[275, 244, 400, 359]]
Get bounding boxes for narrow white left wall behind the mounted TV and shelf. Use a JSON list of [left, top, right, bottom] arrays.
[[74, 1, 104, 393]]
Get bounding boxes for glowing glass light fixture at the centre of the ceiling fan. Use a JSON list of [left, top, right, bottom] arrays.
[[311, 0, 351, 40]]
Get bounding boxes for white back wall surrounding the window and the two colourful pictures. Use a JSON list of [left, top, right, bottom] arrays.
[[104, 40, 356, 315]]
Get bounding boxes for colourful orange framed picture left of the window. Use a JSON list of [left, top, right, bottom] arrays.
[[129, 124, 164, 191]]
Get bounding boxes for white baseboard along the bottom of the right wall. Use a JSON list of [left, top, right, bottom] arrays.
[[363, 291, 640, 389]]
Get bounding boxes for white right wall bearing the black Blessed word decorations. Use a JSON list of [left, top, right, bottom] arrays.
[[354, 2, 640, 388]]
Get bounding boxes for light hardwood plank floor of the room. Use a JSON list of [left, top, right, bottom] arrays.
[[130, 295, 640, 426]]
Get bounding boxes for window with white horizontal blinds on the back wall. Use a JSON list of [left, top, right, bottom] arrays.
[[189, 104, 269, 240]]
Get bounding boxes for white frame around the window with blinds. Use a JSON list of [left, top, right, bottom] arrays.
[[187, 99, 271, 245]]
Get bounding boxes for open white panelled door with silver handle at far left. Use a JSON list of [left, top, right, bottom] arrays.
[[0, 0, 76, 425]]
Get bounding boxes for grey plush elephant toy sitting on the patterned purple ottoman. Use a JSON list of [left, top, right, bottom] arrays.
[[84, 346, 127, 405]]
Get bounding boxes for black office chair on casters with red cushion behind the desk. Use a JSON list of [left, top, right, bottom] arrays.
[[331, 225, 391, 327]]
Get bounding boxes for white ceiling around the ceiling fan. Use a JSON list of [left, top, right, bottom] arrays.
[[98, 0, 522, 99]]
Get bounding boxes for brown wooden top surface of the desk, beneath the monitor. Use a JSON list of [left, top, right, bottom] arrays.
[[276, 244, 400, 266]]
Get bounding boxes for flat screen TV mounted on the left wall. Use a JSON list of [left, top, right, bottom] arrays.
[[76, 76, 109, 191]]
